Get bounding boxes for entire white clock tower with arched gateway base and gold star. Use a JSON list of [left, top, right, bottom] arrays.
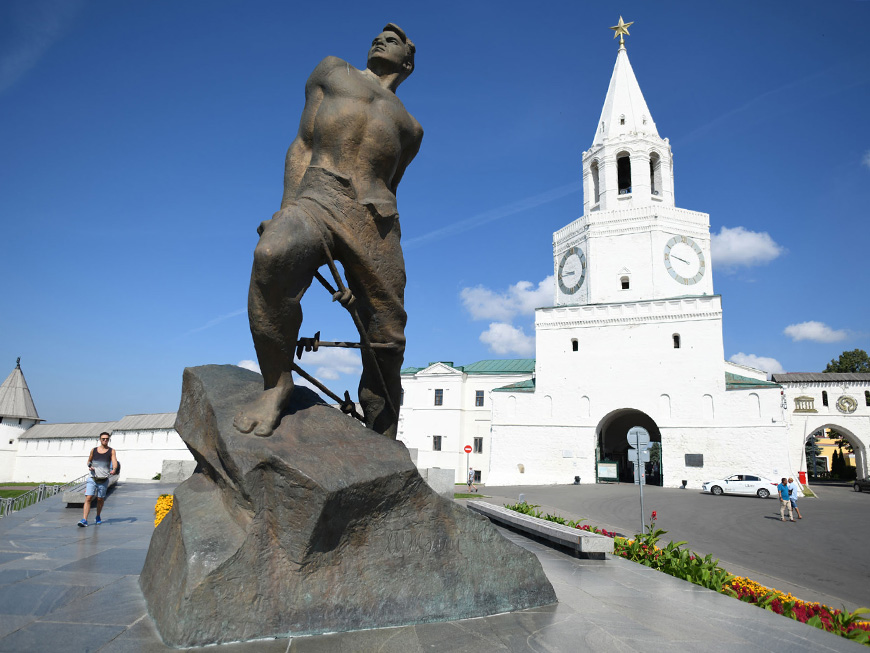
[[487, 18, 803, 487]]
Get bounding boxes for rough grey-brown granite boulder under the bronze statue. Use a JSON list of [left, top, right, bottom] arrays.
[[140, 365, 556, 647]]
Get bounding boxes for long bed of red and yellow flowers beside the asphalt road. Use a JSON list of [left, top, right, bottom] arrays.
[[505, 503, 870, 645]]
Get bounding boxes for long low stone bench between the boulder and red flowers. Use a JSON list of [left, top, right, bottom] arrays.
[[466, 501, 613, 560]]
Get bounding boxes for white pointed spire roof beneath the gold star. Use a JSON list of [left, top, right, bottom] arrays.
[[592, 44, 659, 147]]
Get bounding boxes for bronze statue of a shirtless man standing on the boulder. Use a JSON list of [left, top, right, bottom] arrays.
[[235, 23, 423, 438]]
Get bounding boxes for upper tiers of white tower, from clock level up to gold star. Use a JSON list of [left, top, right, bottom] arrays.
[[553, 23, 713, 306]]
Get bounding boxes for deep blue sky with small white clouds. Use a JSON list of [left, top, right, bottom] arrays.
[[0, 0, 870, 422]]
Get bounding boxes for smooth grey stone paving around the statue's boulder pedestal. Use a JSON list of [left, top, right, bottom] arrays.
[[0, 483, 861, 653]]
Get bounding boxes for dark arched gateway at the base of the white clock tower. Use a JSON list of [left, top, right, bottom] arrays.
[[597, 408, 664, 485]]
